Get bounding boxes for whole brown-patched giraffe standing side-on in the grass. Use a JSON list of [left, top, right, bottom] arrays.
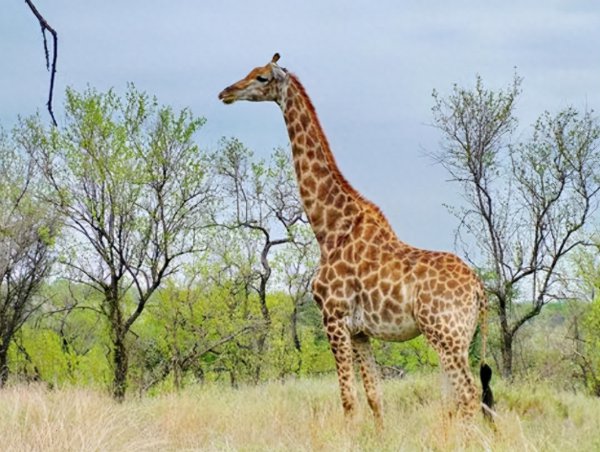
[[219, 54, 493, 427]]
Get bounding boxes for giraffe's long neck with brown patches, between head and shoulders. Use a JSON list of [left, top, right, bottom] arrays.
[[280, 75, 370, 248]]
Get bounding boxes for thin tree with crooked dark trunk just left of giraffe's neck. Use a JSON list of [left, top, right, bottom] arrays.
[[215, 139, 307, 381]]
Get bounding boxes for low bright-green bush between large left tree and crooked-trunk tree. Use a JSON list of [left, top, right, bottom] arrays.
[[129, 258, 257, 391]]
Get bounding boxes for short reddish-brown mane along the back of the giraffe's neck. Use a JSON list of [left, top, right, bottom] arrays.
[[289, 73, 395, 235]]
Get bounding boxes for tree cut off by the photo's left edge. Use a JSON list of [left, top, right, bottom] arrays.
[[0, 130, 59, 387]]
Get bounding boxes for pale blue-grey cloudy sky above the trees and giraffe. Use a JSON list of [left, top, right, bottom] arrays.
[[0, 0, 600, 251]]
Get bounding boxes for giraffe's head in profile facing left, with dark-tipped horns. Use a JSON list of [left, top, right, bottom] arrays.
[[219, 53, 288, 104]]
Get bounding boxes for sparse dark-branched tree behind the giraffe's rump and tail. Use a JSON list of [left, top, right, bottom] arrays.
[[432, 75, 600, 377]]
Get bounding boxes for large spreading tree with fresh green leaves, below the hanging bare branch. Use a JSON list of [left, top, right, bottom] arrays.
[[21, 85, 211, 400]]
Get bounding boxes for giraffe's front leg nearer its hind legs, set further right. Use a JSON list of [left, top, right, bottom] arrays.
[[352, 335, 383, 429]]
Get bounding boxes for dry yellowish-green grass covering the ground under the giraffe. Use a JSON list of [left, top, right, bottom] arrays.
[[0, 375, 600, 452]]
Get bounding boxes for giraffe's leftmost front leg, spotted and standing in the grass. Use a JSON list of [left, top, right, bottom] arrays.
[[324, 318, 357, 419]]
